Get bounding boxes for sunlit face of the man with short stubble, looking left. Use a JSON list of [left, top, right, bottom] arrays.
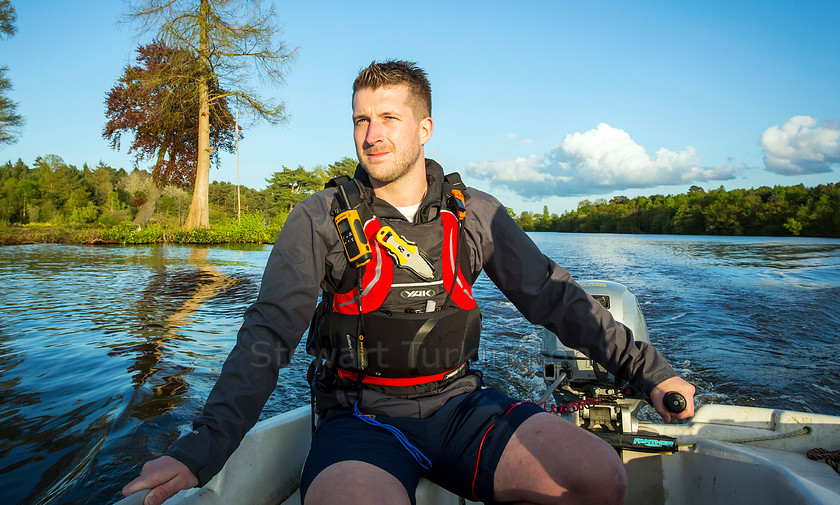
[[353, 85, 432, 184]]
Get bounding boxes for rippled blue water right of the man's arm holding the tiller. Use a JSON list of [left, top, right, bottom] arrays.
[[524, 234, 840, 415]]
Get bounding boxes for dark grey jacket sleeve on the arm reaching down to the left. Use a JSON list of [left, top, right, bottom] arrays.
[[167, 193, 335, 486]]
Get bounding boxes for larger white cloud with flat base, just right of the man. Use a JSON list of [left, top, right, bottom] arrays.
[[465, 123, 736, 198]]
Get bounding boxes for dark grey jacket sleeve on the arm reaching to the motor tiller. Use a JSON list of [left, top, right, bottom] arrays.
[[466, 188, 676, 394]]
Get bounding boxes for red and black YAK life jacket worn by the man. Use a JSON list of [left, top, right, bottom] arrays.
[[307, 174, 481, 387]]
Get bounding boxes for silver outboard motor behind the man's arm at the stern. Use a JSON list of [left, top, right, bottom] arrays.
[[540, 280, 649, 433]]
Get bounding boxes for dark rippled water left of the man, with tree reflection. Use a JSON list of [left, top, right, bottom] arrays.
[[0, 242, 256, 504]]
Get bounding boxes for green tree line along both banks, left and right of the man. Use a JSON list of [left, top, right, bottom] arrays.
[[0, 155, 840, 237]]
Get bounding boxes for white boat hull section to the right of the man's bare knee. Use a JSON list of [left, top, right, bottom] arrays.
[[623, 405, 840, 505]]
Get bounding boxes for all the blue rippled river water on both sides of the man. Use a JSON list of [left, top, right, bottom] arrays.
[[0, 233, 840, 504]]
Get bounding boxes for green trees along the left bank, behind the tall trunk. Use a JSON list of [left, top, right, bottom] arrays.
[[0, 155, 356, 227]]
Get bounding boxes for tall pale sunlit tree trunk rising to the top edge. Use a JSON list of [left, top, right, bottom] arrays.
[[186, 0, 210, 230]]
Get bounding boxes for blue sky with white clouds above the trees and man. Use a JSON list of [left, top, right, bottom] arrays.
[[0, 0, 840, 213]]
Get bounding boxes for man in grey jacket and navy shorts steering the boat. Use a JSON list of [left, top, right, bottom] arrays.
[[123, 61, 694, 505]]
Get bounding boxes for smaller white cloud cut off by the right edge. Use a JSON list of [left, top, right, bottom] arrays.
[[761, 116, 840, 175]]
